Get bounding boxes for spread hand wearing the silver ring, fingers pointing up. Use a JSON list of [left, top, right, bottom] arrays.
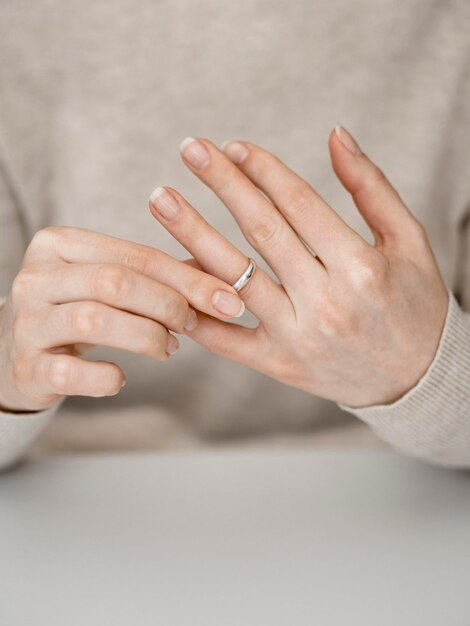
[[152, 127, 448, 407]]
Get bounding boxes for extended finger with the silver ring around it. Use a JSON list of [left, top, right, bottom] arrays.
[[149, 182, 292, 321]]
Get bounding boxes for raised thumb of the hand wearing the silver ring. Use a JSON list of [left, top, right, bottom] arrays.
[[329, 126, 422, 248]]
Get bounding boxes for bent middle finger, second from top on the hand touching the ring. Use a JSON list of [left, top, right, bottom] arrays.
[[35, 263, 197, 332]]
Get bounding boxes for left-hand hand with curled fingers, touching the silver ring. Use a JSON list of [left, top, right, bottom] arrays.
[[0, 227, 244, 412]]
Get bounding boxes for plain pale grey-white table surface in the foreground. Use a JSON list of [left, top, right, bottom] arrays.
[[0, 451, 470, 626]]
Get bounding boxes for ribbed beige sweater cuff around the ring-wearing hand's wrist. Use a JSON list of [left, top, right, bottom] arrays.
[[338, 290, 470, 466]]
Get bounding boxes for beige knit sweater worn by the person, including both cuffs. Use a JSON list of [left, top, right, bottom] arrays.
[[0, 0, 470, 466]]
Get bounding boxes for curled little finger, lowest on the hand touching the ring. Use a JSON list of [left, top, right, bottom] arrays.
[[34, 352, 126, 397]]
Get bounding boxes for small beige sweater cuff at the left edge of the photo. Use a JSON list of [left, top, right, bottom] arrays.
[[0, 402, 61, 471]]
